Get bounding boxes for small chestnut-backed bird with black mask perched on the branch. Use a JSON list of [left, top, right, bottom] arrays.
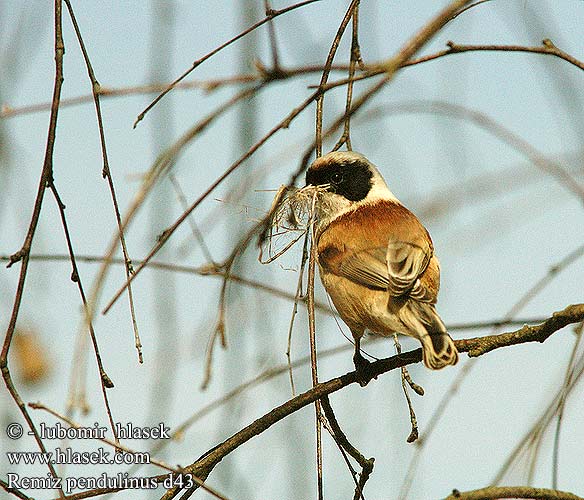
[[306, 151, 458, 385]]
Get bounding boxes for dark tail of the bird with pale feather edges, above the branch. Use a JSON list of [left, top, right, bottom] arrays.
[[402, 302, 458, 370]]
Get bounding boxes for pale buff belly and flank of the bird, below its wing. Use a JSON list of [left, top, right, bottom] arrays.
[[320, 269, 404, 337]]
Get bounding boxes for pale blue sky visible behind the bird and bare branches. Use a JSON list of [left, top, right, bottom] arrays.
[[0, 0, 584, 500]]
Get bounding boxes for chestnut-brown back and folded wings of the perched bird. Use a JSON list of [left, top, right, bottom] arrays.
[[318, 201, 440, 302]]
